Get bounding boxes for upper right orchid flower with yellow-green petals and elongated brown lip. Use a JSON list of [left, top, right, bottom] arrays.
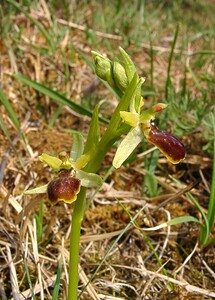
[[113, 103, 185, 168]]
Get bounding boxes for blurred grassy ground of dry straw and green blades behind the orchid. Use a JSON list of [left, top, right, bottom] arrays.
[[0, 0, 215, 300]]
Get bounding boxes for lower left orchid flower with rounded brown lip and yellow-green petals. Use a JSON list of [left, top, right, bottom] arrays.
[[25, 134, 102, 205]]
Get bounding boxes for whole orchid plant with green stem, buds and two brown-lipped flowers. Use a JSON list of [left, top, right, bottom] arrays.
[[25, 48, 185, 300]]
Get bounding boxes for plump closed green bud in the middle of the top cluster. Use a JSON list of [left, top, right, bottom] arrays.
[[113, 60, 128, 92]]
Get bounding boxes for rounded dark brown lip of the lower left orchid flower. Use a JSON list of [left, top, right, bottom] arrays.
[[47, 170, 81, 205]]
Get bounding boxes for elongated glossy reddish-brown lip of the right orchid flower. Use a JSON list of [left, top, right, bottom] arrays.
[[147, 122, 186, 164]]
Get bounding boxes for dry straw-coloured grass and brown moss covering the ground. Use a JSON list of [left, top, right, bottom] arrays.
[[0, 1, 215, 300]]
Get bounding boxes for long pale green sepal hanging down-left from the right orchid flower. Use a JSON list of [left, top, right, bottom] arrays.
[[113, 126, 143, 168]]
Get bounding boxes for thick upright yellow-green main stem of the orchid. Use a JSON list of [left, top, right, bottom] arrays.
[[68, 75, 141, 300]]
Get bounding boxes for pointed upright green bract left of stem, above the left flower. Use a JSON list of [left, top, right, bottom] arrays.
[[84, 105, 100, 153]]
